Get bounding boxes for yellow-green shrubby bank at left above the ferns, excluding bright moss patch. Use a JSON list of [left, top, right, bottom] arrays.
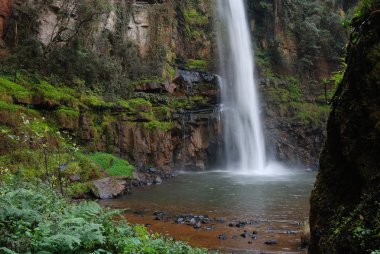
[[0, 114, 99, 194]]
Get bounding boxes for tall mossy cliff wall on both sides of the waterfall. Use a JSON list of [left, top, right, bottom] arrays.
[[0, 0, 354, 169]]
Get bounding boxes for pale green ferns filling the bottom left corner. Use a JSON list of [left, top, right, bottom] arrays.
[[0, 179, 207, 253]]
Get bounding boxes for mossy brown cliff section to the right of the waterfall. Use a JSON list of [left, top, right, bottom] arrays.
[[247, 0, 357, 169]]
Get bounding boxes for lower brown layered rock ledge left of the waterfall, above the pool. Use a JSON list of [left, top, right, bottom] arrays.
[[74, 71, 222, 174]]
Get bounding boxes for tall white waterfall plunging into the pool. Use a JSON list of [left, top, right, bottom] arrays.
[[217, 0, 266, 172]]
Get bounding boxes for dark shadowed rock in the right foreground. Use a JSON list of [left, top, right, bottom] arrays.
[[309, 8, 380, 254]]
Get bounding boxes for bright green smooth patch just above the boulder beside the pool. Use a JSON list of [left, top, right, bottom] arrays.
[[86, 152, 134, 176]]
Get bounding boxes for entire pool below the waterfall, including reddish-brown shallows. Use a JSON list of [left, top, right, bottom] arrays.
[[101, 170, 316, 253]]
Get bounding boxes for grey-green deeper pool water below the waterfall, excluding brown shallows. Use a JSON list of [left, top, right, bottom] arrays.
[[102, 171, 316, 220]]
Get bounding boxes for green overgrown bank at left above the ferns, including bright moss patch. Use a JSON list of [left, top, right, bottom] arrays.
[[0, 99, 134, 197]]
